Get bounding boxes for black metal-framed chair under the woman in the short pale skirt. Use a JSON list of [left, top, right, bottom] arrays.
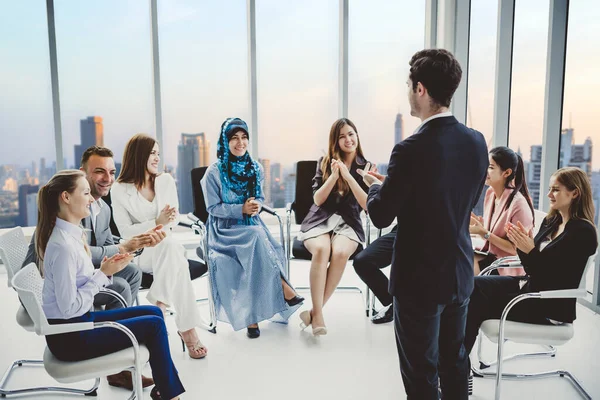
[[286, 160, 371, 316]]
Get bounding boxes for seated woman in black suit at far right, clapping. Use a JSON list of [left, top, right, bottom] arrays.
[[465, 167, 598, 372]]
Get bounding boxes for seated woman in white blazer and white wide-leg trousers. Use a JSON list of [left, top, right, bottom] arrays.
[[111, 134, 207, 358]]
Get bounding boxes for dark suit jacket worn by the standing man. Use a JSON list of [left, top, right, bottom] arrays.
[[367, 116, 489, 304]]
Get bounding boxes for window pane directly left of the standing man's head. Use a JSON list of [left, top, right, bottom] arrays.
[[348, 0, 425, 168]]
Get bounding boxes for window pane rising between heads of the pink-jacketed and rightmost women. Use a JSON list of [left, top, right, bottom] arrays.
[[509, 0, 550, 209]]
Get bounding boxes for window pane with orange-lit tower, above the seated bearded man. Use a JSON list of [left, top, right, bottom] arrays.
[[54, 0, 155, 169]]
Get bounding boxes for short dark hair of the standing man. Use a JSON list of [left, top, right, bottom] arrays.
[[408, 49, 462, 107]]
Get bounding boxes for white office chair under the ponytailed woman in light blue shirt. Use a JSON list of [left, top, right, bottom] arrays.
[[8, 263, 149, 400]]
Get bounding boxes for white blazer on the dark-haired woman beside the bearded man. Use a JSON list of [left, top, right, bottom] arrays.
[[110, 173, 179, 239]]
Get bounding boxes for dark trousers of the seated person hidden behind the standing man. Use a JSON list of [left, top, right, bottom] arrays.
[[354, 225, 398, 306]]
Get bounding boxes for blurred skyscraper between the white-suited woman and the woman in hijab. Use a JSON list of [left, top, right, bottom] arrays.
[[177, 132, 210, 213]]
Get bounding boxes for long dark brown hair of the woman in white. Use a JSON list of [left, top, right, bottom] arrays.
[[117, 133, 157, 190]]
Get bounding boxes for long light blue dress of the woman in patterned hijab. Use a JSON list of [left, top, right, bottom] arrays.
[[201, 163, 300, 331]]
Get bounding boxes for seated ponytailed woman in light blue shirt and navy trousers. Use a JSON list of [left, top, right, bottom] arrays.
[[36, 170, 185, 399]]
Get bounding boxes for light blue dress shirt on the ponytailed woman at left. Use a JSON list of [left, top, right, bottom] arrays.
[[42, 218, 112, 319]]
